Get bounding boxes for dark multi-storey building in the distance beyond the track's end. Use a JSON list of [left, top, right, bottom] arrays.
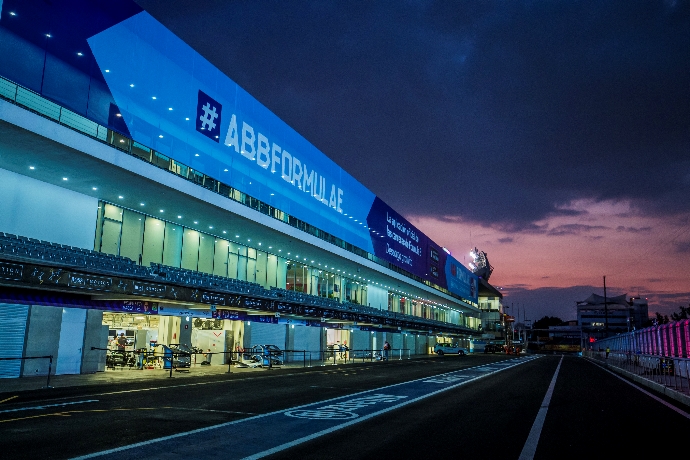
[[577, 294, 649, 338]]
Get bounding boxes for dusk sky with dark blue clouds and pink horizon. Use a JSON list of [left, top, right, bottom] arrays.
[[137, 0, 690, 321]]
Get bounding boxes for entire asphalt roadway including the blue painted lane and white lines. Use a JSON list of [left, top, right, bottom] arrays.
[[0, 355, 690, 460]]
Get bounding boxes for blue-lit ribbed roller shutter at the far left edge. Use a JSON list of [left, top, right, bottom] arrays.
[[0, 304, 29, 378]]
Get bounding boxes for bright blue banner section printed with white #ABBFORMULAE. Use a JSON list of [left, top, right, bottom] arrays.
[[88, 12, 374, 252]]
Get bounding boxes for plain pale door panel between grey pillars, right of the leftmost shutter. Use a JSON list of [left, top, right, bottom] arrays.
[[55, 308, 86, 375]]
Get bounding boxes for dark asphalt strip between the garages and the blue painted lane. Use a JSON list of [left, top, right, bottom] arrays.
[[0, 354, 512, 459]]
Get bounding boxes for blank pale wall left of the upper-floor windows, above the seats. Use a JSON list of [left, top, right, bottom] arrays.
[[0, 169, 98, 249]]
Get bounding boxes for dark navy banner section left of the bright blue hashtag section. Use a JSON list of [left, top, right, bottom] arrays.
[[0, 0, 142, 134]]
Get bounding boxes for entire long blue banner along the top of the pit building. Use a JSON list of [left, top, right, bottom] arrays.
[[0, 0, 477, 302]]
